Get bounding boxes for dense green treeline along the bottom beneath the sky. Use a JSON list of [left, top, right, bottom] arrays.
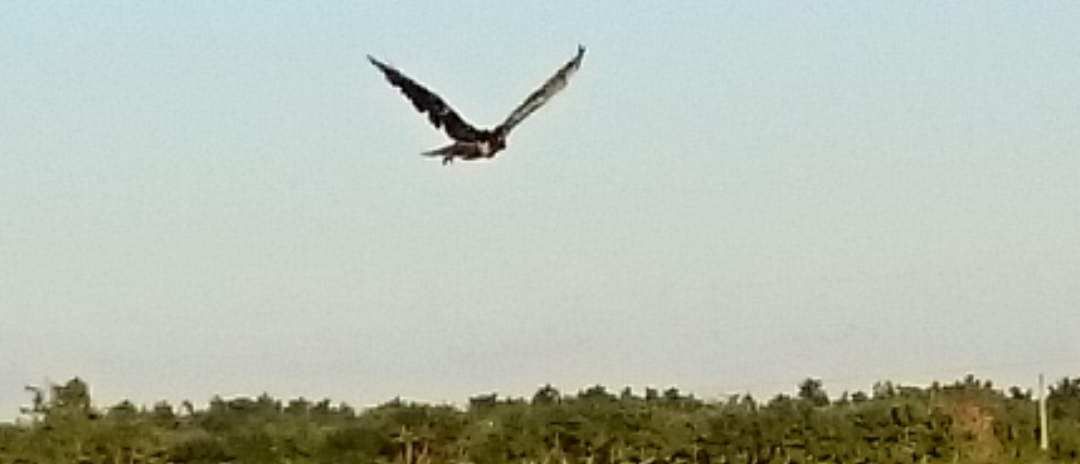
[[0, 377, 1080, 464]]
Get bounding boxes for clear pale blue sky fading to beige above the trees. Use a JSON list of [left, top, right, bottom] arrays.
[[0, 0, 1080, 417]]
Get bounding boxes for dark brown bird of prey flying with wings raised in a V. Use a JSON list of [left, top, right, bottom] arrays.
[[367, 45, 585, 165]]
